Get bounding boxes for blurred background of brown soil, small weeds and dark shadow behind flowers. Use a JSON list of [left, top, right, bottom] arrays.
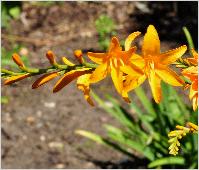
[[1, 1, 198, 168]]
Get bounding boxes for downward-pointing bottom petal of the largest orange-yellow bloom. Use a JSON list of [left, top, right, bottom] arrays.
[[149, 71, 162, 103]]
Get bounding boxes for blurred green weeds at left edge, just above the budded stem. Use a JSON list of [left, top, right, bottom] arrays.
[[1, 44, 29, 69]]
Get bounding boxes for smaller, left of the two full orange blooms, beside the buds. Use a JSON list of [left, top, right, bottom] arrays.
[[88, 37, 140, 101]]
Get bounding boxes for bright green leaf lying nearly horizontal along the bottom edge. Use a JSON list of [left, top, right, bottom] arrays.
[[148, 157, 185, 168]]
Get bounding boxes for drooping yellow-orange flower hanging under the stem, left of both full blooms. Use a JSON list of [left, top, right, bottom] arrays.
[[77, 74, 94, 106]]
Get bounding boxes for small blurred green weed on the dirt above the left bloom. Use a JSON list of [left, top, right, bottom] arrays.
[[95, 15, 116, 50]]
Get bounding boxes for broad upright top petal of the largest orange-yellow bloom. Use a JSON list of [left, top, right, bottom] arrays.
[[142, 25, 160, 56]]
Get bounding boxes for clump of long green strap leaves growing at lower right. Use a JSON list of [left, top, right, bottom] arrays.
[[77, 84, 198, 168]]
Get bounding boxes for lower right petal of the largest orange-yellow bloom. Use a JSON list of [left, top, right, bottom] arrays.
[[155, 66, 184, 86]]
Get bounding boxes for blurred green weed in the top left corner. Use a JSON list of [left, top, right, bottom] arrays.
[[1, 1, 21, 28]]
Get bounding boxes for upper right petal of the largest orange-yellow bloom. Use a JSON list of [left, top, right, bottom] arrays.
[[159, 45, 187, 65]]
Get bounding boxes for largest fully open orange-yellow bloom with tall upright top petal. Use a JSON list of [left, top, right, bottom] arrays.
[[126, 25, 187, 103]]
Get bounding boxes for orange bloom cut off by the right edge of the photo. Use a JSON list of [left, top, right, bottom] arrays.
[[182, 66, 198, 110]]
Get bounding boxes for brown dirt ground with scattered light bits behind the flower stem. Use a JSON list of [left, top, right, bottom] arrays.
[[1, 2, 195, 169]]
